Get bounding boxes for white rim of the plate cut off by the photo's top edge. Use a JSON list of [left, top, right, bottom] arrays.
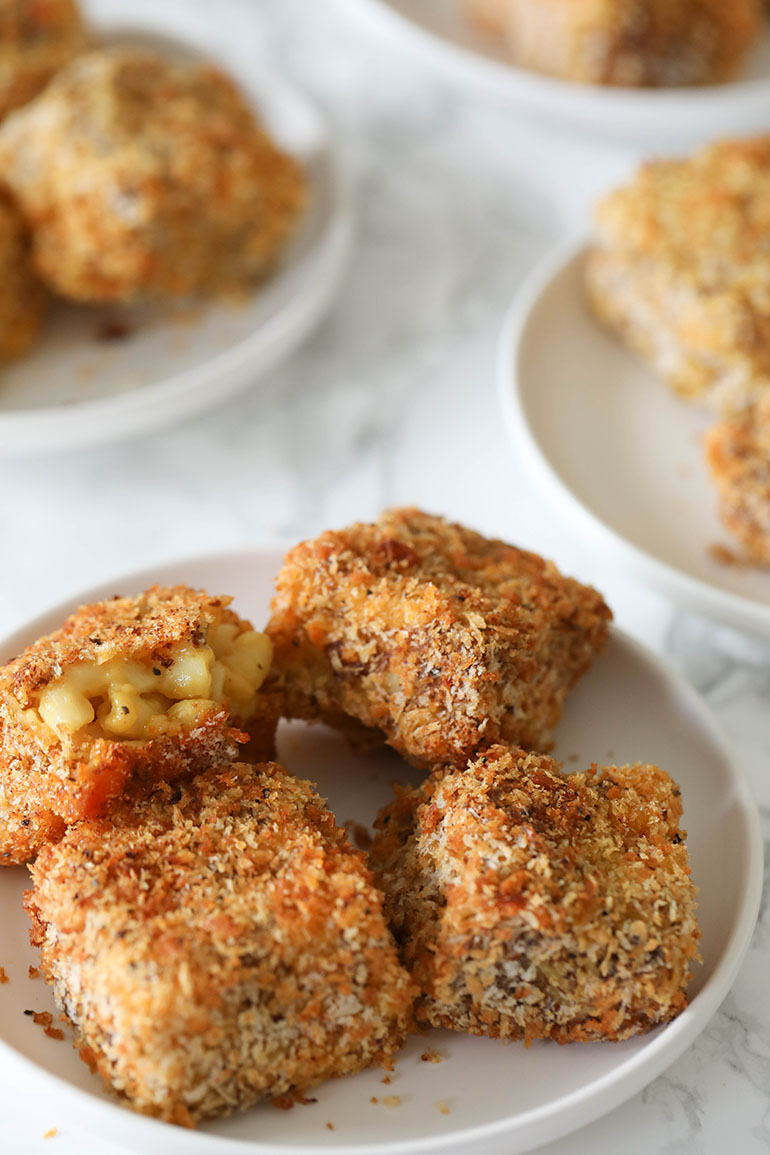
[[337, 0, 770, 141]]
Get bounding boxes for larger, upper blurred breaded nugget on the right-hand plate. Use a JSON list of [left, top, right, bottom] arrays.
[[586, 136, 770, 412]]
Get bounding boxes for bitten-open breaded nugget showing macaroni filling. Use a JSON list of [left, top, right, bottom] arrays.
[[0, 586, 277, 865]]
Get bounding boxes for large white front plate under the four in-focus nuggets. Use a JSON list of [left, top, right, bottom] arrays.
[[0, 550, 762, 1155]]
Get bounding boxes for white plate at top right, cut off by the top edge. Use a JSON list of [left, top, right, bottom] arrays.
[[344, 0, 770, 149]]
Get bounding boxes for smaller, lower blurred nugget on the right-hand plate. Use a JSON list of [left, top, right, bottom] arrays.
[[705, 395, 770, 566]]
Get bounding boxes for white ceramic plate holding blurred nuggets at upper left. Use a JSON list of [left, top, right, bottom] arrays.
[[0, 12, 352, 454]]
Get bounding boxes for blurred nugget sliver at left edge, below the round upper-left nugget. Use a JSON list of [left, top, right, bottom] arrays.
[[0, 191, 48, 360]]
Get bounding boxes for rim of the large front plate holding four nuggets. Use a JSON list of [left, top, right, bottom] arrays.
[[0, 541, 764, 1155]]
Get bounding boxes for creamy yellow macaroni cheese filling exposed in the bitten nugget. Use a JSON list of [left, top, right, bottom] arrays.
[[37, 623, 272, 739]]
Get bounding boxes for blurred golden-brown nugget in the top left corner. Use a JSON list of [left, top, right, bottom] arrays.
[[0, 0, 89, 119]]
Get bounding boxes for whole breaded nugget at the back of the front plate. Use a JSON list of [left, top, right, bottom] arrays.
[[267, 509, 611, 767]]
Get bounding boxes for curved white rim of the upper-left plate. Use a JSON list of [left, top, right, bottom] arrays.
[[0, 20, 356, 457]]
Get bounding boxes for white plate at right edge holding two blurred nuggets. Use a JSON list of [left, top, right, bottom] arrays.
[[499, 244, 770, 638]]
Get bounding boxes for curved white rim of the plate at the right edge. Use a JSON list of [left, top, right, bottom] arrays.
[[496, 233, 770, 638]]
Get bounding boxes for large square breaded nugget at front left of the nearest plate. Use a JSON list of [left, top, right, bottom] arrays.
[[25, 763, 414, 1126]]
